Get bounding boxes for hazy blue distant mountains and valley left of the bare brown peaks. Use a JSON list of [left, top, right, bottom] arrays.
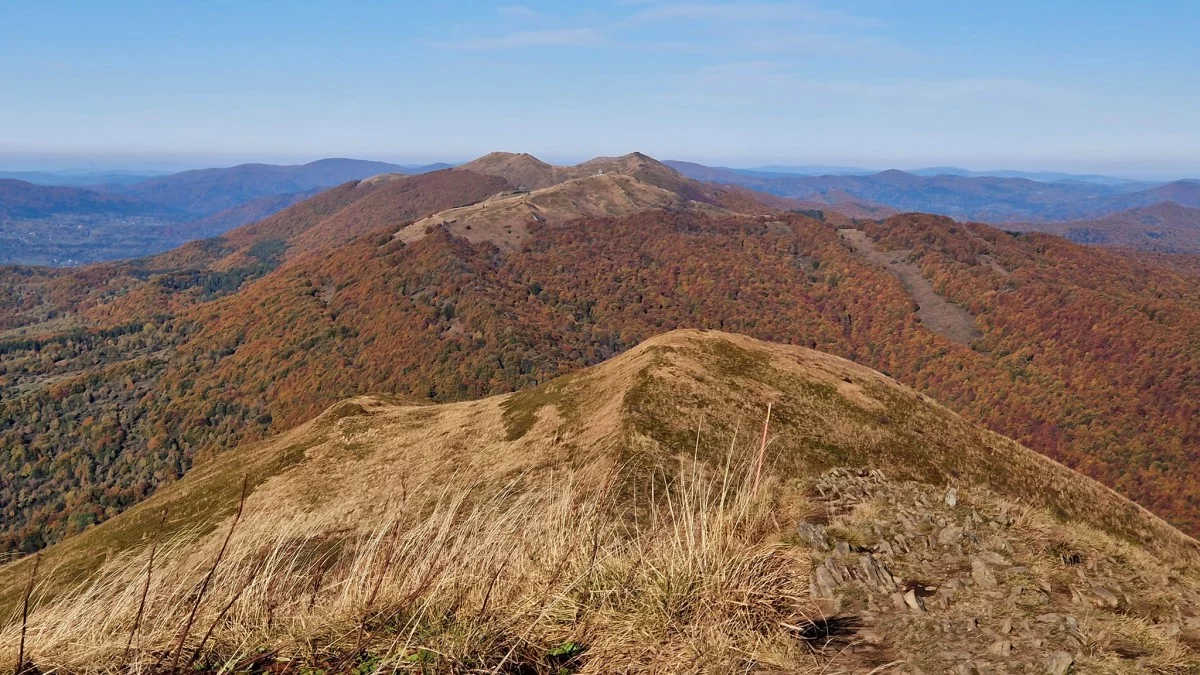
[[0, 159, 449, 265]]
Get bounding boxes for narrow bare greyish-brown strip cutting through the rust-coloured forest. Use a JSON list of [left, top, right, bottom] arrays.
[[838, 229, 983, 345]]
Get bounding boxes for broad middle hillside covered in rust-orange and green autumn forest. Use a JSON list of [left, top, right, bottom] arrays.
[[0, 153, 1200, 550]]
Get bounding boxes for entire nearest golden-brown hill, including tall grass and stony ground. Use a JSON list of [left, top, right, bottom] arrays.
[[0, 330, 1200, 674]]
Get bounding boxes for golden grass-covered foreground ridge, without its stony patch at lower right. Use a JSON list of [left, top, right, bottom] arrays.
[[0, 330, 1200, 673]]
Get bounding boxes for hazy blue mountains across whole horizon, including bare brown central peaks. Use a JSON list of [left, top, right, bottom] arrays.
[[0, 153, 1200, 265]]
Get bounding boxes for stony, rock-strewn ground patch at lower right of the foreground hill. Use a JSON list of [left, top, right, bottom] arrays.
[[797, 470, 1200, 675]]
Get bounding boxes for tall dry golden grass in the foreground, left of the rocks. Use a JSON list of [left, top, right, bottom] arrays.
[[0, 454, 835, 673]]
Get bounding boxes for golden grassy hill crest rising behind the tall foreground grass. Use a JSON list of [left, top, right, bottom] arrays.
[[9, 330, 1196, 607]]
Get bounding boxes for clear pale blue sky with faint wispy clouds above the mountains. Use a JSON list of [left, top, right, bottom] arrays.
[[0, 0, 1200, 175]]
